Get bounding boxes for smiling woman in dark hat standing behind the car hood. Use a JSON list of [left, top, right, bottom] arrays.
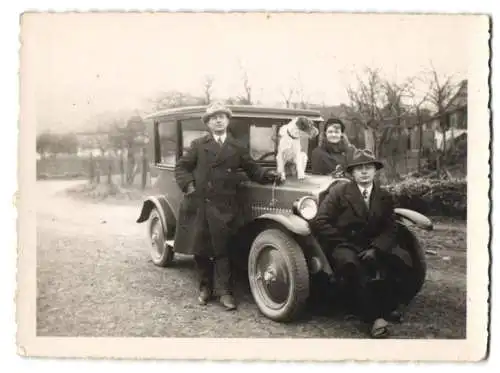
[[311, 118, 356, 175]]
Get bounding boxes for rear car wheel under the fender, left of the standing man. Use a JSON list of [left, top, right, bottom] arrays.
[[148, 208, 174, 267]]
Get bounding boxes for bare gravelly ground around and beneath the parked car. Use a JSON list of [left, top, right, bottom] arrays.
[[36, 181, 466, 338]]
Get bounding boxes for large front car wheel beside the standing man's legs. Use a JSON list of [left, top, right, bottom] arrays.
[[248, 229, 310, 322]]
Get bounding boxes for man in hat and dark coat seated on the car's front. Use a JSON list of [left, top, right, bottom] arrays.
[[311, 150, 412, 338]]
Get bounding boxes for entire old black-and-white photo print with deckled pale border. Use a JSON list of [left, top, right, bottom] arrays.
[[17, 12, 490, 360]]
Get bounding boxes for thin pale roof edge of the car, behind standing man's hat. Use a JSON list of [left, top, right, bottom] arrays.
[[145, 105, 323, 120]]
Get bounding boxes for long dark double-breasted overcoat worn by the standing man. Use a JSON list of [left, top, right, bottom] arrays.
[[175, 133, 272, 257]]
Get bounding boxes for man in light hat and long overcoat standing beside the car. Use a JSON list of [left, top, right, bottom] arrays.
[[175, 104, 280, 310]]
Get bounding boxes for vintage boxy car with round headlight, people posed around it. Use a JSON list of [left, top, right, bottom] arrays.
[[137, 105, 432, 322]]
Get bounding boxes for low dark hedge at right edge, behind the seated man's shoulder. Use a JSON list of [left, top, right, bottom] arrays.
[[385, 178, 467, 219]]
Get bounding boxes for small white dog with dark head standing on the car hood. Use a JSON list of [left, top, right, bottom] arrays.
[[276, 116, 319, 181]]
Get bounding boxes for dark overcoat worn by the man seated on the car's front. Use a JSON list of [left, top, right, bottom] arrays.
[[311, 181, 409, 264]]
